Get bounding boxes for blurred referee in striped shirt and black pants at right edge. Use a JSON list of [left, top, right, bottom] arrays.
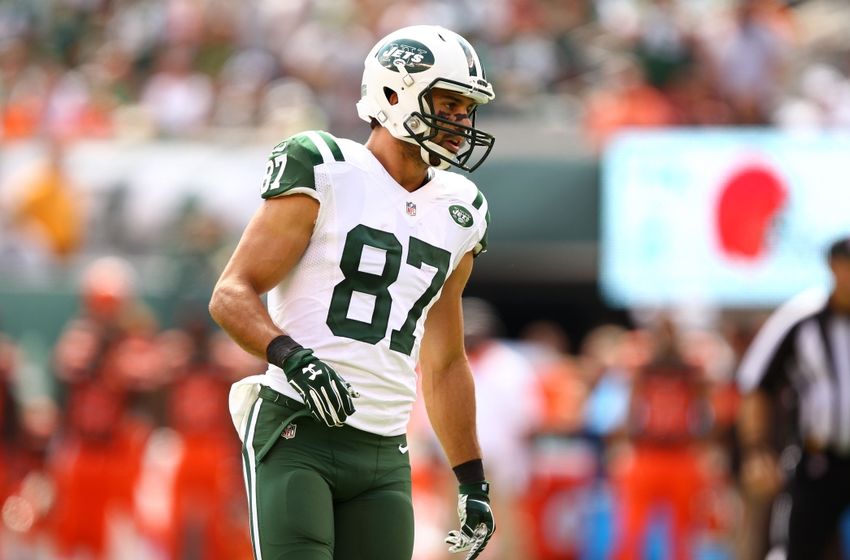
[[738, 237, 850, 560]]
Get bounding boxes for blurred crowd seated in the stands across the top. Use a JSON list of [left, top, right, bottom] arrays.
[[0, 0, 850, 147]]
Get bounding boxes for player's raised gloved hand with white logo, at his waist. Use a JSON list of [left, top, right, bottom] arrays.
[[283, 348, 360, 427]]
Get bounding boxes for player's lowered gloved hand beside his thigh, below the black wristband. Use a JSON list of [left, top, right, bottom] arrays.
[[446, 482, 496, 560]]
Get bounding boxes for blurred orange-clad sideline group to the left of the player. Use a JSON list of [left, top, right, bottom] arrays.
[[0, 257, 264, 560]]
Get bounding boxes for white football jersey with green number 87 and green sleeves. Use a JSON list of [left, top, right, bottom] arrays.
[[255, 131, 489, 436]]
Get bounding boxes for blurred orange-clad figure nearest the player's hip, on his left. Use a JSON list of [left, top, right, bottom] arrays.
[[135, 313, 251, 560]]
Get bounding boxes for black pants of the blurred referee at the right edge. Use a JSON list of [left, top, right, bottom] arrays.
[[786, 452, 850, 560]]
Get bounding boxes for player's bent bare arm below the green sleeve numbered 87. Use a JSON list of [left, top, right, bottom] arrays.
[[209, 194, 319, 359]]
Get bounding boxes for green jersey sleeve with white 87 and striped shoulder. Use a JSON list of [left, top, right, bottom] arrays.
[[262, 131, 345, 198]]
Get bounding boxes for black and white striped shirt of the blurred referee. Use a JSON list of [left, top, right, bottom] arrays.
[[738, 290, 850, 454]]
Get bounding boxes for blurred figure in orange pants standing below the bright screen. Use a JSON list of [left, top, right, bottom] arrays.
[[615, 321, 710, 560]]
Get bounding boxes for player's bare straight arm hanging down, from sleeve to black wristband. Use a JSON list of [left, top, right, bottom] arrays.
[[419, 253, 481, 467]]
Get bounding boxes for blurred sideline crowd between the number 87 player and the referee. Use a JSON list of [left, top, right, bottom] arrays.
[[411, 298, 752, 560]]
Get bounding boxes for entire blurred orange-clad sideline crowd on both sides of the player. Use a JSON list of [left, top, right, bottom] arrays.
[[0, 257, 766, 560]]
